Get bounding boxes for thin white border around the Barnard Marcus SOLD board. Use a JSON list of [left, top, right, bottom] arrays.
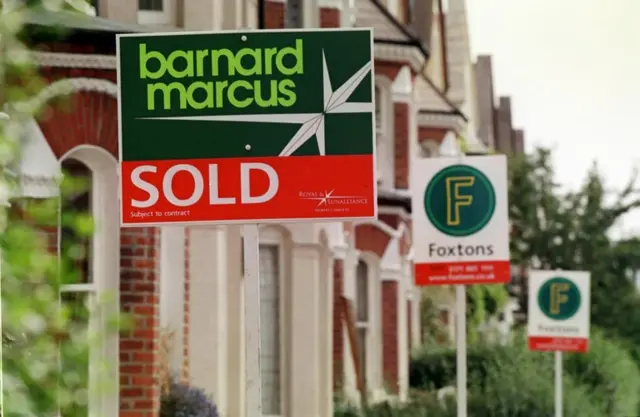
[[116, 27, 378, 227]]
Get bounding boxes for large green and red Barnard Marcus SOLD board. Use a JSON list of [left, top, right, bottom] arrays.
[[117, 29, 377, 226]]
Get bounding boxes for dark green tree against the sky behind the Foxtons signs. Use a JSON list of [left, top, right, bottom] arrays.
[[509, 148, 640, 338]]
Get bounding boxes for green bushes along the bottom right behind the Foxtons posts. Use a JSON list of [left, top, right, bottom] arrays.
[[410, 331, 640, 417]]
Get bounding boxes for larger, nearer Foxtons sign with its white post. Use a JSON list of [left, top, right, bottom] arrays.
[[411, 155, 510, 417]]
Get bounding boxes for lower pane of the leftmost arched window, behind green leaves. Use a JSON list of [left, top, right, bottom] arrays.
[[60, 292, 91, 417]]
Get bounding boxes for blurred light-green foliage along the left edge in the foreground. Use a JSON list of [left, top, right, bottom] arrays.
[[0, 1, 125, 417]]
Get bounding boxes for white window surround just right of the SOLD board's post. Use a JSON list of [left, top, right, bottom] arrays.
[[258, 227, 289, 417]]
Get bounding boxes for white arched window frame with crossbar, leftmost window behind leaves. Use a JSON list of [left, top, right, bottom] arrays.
[[56, 145, 120, 417]]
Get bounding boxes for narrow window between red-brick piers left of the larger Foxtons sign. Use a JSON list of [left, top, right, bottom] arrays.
[[355, 261, 370, 392]]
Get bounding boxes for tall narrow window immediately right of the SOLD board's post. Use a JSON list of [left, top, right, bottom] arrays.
[[260, 245, 282, 416]]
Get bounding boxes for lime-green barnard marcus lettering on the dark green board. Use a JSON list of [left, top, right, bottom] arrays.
[[139, 39, 304, 110]]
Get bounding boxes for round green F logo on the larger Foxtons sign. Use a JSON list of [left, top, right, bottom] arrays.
[[424, 165, 496, 237]]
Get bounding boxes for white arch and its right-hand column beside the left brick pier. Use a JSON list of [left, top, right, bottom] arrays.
[[58, 145, 120, 417]]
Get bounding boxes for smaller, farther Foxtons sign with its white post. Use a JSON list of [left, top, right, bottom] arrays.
[[528, 271, 591, 417]]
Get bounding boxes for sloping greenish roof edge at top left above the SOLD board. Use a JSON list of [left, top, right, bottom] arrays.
[[25, 8, 149, 34]]
